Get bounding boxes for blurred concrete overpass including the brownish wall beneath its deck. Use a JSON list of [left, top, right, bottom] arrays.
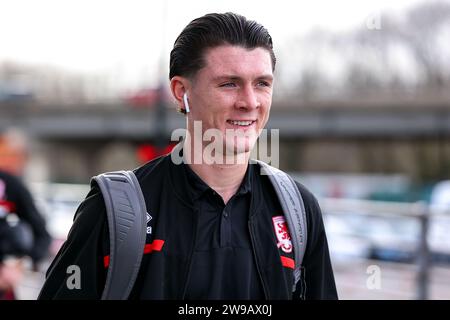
[[0, 101, 450, 182]]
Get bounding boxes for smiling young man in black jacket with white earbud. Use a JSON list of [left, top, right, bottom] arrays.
[[40, 13, 337, 299]]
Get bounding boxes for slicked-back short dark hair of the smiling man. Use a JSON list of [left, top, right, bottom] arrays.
[[169, 12, 276, 79]]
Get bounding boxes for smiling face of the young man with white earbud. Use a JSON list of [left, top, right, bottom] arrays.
[[188, 45, 273, 154]]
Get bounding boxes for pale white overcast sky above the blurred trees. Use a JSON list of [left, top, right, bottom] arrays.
[[0, 0, 428, 90]]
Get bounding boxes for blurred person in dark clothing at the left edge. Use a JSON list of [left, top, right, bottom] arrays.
[[0, 130, 51, 300]]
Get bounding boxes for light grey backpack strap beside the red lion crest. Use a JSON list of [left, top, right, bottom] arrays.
[[252, 160, 308, 291]]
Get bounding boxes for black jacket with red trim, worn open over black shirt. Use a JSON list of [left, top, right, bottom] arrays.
[[39, 156, 337, 299]]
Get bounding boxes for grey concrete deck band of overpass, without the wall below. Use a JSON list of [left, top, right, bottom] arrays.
[[0, 101, 450, 140]]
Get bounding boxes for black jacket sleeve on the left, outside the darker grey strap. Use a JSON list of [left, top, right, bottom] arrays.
[[38, 188, 108, 300]]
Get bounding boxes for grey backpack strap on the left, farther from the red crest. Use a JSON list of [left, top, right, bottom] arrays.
[[91, 171, 147, 300]]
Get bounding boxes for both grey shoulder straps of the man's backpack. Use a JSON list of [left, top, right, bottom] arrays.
[[91, 160, 307, 300]]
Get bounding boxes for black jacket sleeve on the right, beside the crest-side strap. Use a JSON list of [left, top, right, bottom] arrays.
[[294, 183, 338, 300]]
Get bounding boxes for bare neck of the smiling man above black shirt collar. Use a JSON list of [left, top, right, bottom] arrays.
[[183, 142, 250, 204]]
